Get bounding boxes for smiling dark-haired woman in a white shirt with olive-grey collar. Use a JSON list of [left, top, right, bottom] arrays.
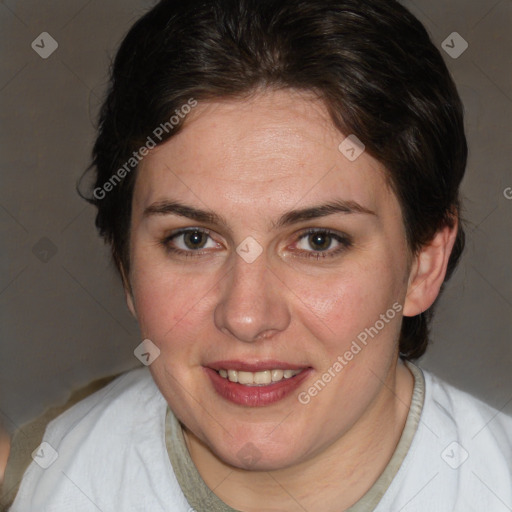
[[12, 0, 512, 512]]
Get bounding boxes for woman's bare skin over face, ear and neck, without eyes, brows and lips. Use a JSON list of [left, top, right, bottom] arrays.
[[126, 90, 456, 512]]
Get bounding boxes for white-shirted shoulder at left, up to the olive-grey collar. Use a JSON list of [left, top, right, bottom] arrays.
[[11, 368, 192, 512]]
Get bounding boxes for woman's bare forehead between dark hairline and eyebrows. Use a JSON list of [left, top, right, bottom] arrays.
[[135, 90, 390, 215]]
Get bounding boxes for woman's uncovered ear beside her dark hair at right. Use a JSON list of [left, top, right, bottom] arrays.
[[403, 218, 458, 316]]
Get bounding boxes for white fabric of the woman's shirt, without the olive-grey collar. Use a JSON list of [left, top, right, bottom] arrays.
[[10, 368, 512, 512]]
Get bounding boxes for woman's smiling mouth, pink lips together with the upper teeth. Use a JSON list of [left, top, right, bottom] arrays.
[[203, 361, 313, 407]]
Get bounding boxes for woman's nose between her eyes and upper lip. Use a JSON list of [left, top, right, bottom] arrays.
[[214, 253, 290, 343]]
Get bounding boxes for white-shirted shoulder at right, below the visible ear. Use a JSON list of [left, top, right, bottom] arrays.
[[376, 364, 512, 512]]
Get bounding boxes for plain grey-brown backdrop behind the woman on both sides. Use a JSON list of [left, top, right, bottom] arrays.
[[0, 0, 512, 431]]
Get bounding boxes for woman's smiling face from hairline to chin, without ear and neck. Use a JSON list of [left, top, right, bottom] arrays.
[[128, 91, 416, 469]]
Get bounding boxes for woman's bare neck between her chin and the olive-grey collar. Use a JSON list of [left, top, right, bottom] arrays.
[[184, 361, 414, 512]]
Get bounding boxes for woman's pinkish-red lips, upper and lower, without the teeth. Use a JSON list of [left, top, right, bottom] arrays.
[[204, 361, 312, 407]]
